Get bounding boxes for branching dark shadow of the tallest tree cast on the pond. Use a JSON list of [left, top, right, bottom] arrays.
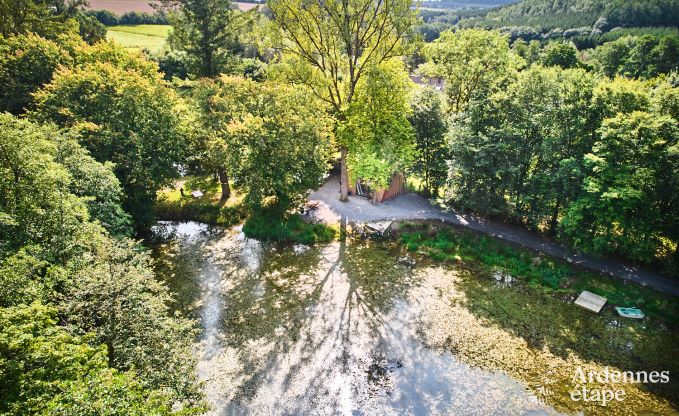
[[223, 219, 420, 414]]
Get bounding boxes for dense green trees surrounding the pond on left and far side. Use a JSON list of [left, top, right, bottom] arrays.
[[0, 0, 679, 415]]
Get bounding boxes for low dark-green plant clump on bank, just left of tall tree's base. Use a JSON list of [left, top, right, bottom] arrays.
[[243, 210, 336, 244]]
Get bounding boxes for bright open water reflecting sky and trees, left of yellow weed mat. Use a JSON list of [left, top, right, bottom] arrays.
[[150, 223, 553, 415]]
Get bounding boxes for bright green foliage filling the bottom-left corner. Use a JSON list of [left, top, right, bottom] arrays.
[[0, 302, 171, 416]]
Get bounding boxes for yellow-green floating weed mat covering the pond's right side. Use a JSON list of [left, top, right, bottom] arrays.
[[409, 265, 679, 415]]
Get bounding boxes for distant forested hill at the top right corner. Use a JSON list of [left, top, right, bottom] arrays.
[[461, 0, 679, 30]]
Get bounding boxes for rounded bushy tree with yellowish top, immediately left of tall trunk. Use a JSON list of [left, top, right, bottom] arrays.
[[201, 77, 331, 215]]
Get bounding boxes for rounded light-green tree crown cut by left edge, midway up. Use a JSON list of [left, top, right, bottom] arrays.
[[0, 113, 92, 261]]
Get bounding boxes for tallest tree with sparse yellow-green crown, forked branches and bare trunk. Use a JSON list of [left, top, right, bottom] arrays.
[[268, 0, 416, 201]]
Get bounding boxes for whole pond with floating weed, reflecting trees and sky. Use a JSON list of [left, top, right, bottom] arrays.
[[150, 222, 677, 415]]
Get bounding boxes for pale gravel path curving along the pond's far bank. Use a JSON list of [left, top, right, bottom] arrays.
[[309, 176, 679, 296]]
